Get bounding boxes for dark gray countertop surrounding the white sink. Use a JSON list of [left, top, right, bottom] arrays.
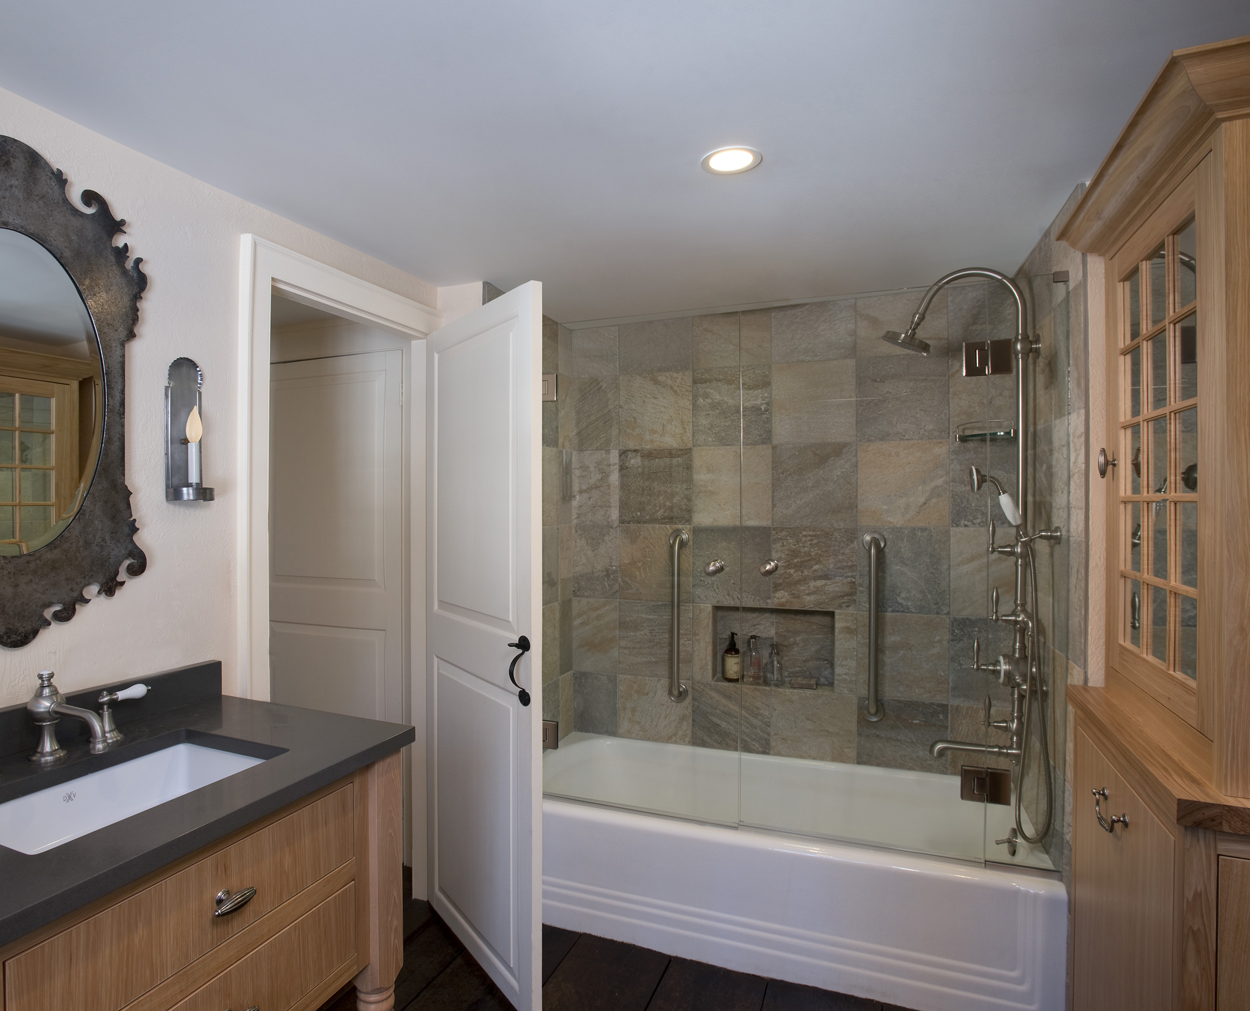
[[0, 667, 416, 946]]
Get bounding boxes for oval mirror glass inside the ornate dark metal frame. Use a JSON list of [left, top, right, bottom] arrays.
[[0, 229, 104, 555]]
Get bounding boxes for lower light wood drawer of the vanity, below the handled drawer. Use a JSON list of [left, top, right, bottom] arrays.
[[170, 884, 356, 1011]]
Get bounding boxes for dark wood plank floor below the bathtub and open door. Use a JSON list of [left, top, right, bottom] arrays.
[[321, 874, 903, 1011]]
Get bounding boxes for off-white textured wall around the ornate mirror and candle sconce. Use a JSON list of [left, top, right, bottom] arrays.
[[0, 90, 438, 706]]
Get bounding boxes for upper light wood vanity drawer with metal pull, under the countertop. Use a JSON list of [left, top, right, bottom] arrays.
[[4, 784, 356, 1011]]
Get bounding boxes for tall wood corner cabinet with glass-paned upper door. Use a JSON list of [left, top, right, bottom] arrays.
[[1059, 39, 1250, 1011]]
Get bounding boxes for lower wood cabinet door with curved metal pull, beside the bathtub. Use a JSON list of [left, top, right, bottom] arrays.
[[1073, 730, 1176, 1011]]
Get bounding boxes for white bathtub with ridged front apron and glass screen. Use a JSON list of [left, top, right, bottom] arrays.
[[543, 734, 1068, 1011]]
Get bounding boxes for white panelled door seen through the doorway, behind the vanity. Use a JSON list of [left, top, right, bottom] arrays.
[[269, 351, 404, 722]]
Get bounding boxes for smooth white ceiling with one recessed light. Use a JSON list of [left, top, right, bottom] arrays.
[[0, 0, 1250, 321]]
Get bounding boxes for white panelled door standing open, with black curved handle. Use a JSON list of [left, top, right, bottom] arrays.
[[425, 281, 543, 1011]]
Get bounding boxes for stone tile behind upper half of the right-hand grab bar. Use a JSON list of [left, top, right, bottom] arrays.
[[858, 526, 950, 615]]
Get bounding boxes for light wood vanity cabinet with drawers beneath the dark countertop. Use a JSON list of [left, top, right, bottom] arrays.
[[0, 755, 403, 1011]]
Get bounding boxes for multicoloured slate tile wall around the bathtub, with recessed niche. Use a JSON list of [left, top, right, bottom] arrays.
[[544, 252, 1075, 801]]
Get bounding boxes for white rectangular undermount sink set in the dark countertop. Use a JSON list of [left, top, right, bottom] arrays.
[[0, 744, 265, 854]]
